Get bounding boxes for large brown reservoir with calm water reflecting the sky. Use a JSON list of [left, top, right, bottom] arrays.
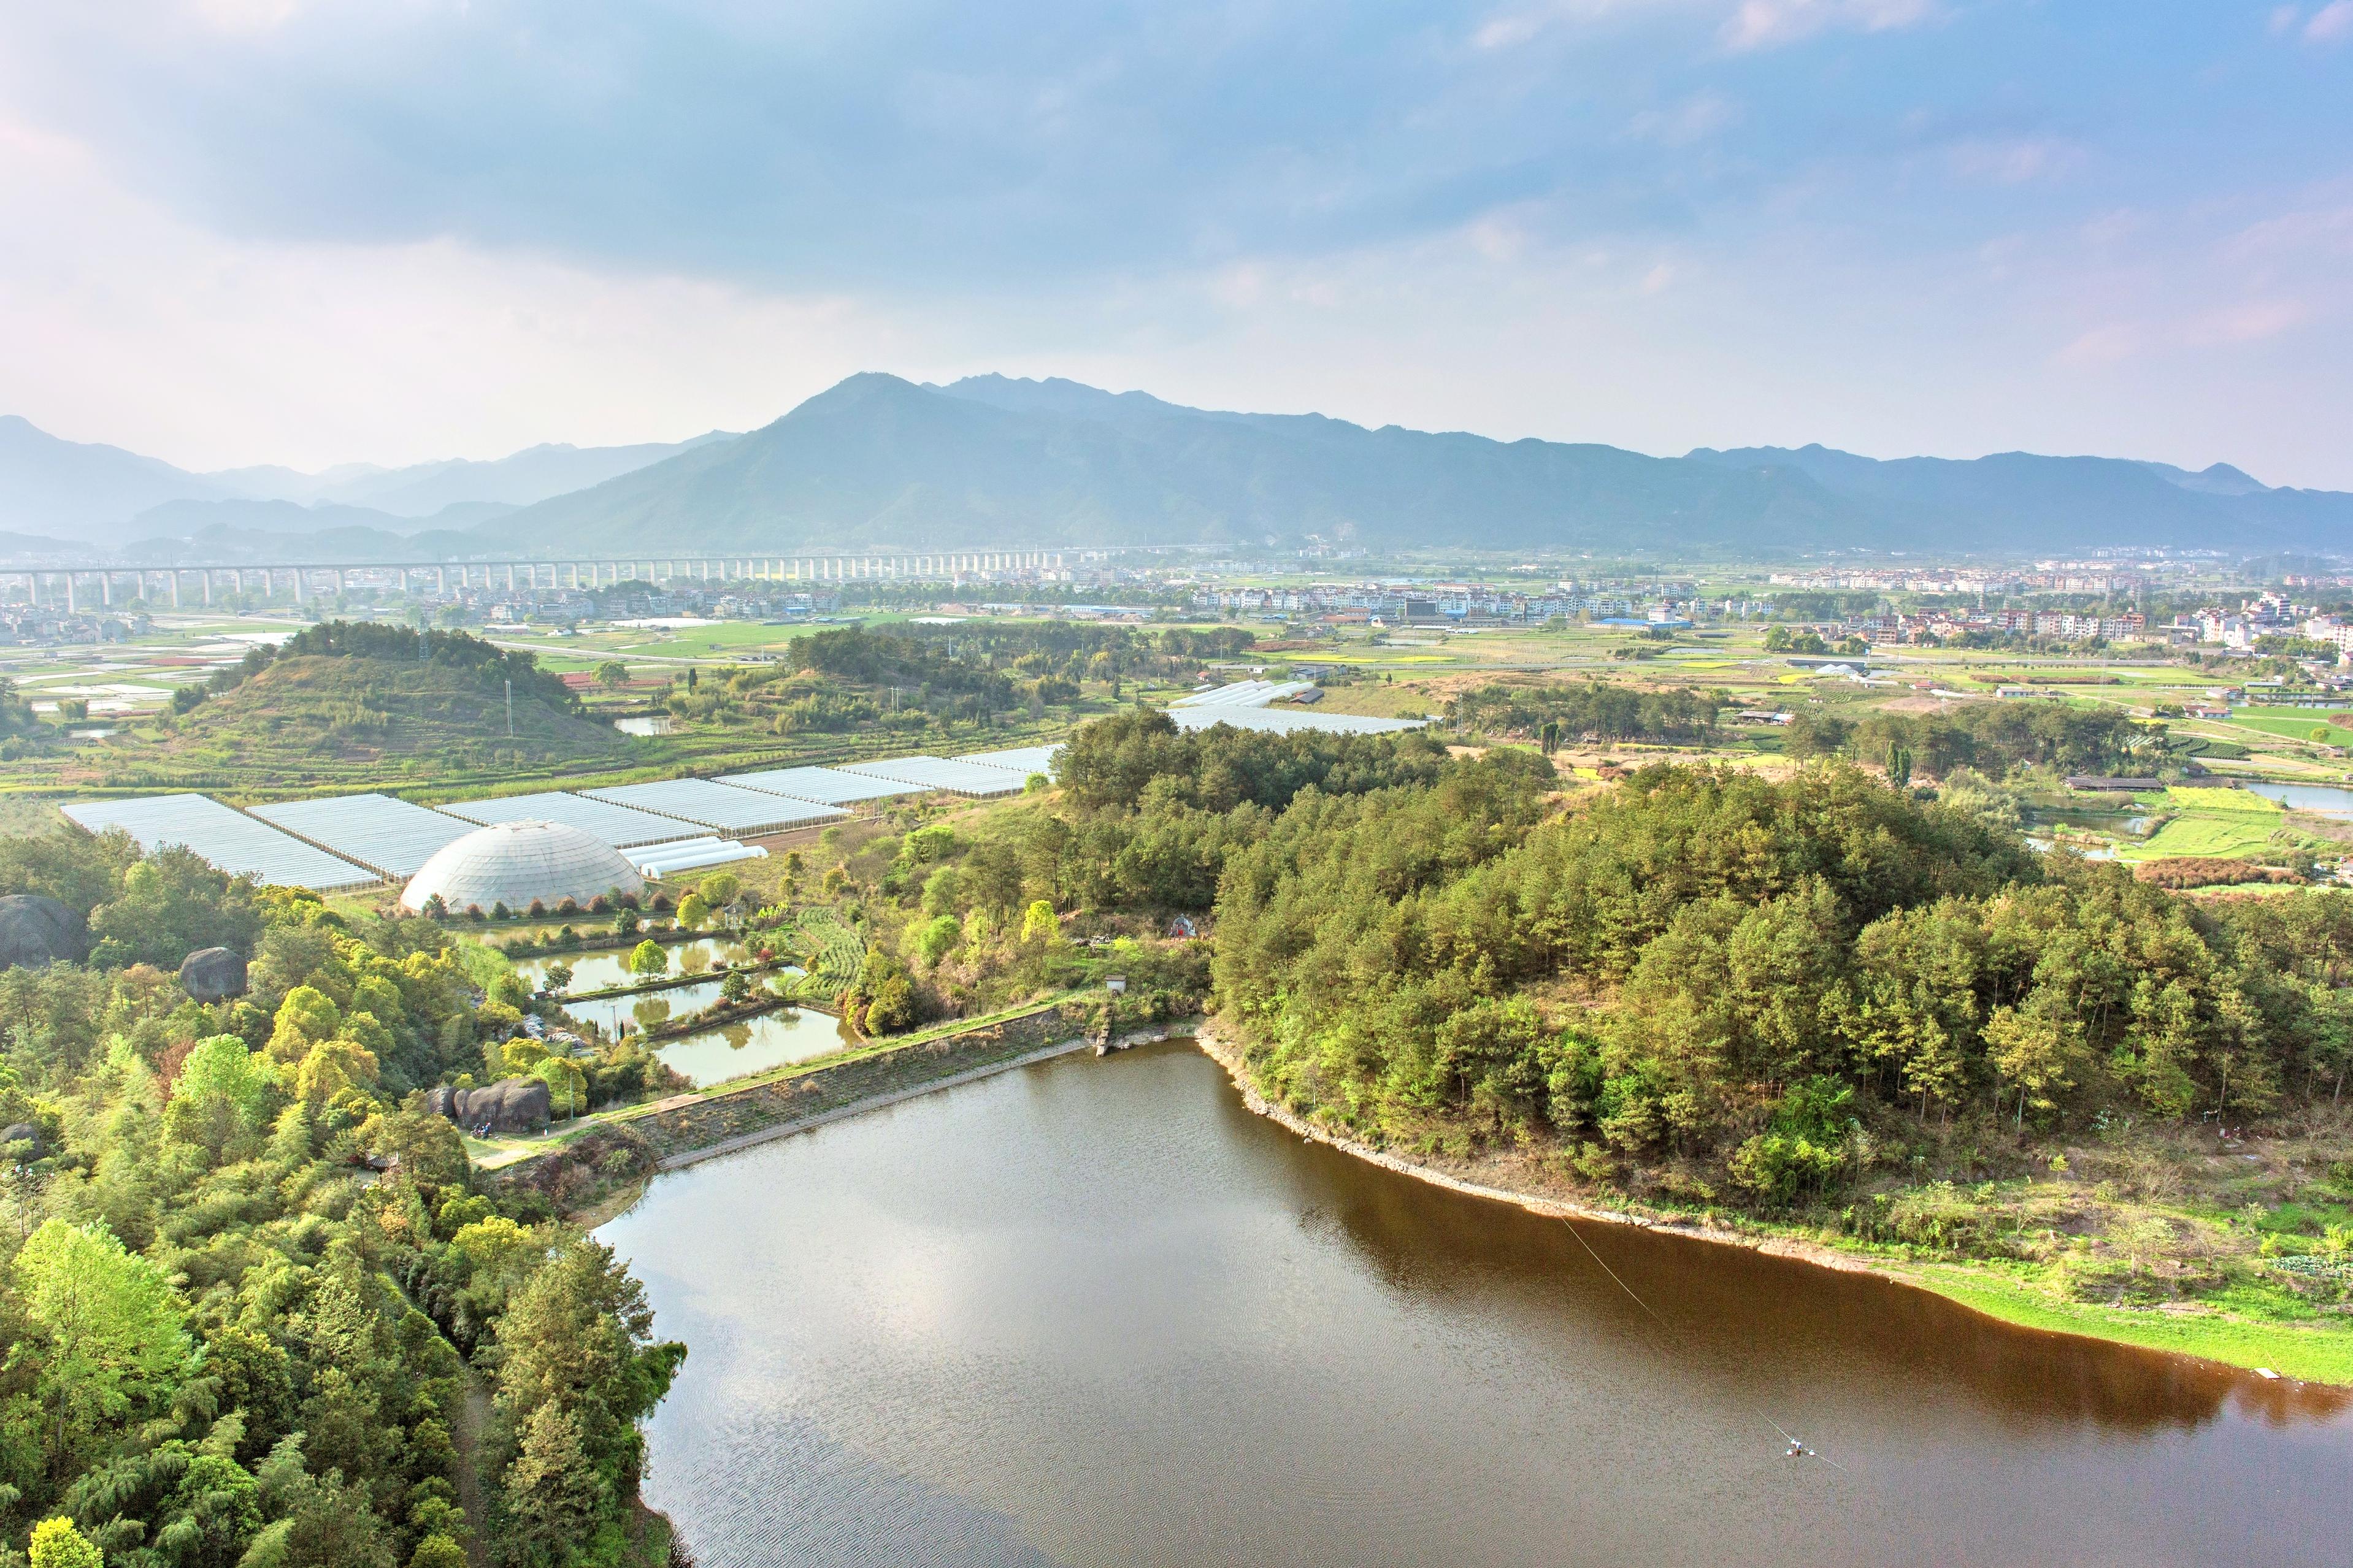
[[602, 1046, 2353, 1568]]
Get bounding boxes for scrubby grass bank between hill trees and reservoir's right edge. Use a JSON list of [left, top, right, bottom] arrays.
[[1202, 1032, 2353, 1387]]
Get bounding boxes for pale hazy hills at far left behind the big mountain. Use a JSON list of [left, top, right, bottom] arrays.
[[0, 414, 732, 559]]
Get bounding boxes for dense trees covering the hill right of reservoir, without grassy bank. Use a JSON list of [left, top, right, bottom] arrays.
[[936, 713, 2353, 1206]]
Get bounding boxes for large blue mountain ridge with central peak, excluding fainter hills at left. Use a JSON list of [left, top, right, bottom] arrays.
[[496, 374, 2353, 555]]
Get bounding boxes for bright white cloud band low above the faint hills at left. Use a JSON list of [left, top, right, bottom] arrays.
[[0, 122, 918, 468]]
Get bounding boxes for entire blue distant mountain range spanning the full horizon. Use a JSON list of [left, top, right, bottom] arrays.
[[0, 374, 2353, 559]]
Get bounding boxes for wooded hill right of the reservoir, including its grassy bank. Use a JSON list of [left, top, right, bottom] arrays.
[[969, 714, 2353, 1380]]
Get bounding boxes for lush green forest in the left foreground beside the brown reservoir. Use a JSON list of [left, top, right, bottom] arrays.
[[0, 832, 685, 1568]]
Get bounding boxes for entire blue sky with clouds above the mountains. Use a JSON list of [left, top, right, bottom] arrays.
[[0, 0, 2353, 489]]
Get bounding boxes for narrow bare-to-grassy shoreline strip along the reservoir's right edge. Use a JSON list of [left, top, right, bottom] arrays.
[[1193, 1020, 2353, 1387]]
